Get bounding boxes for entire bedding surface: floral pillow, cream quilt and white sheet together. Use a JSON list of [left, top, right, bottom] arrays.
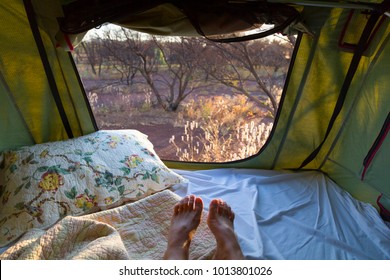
[[0, 130, 390, 260]]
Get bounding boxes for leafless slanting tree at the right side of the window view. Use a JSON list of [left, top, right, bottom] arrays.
[[205, 40, 291, 118]]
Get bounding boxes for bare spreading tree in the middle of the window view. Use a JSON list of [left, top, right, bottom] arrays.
[[98, 28, 204, 111]]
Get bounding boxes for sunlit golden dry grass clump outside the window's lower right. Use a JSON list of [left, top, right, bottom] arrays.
[[169, 96, 272, 162]]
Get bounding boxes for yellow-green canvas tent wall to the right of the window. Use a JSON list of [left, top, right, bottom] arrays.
[[274, 6, 390, 203]]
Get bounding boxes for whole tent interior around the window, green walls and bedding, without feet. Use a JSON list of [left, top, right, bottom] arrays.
[[0, 0, 390, 259]]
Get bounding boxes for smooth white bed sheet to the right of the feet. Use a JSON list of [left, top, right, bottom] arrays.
[[173, 168, 390, 260]]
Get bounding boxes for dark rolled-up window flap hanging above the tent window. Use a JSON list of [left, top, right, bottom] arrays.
[[60, 0, 302, 42]]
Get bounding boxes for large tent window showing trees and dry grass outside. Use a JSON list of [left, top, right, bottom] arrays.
[[73, 25, 294, 162]]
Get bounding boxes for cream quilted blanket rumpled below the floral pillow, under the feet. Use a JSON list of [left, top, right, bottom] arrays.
[[0, 190, 215, 260]]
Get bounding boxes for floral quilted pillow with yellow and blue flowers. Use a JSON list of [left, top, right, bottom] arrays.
[[0, 130, 186, 246]]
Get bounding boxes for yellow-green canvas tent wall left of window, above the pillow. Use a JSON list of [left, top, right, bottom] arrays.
[[0, 1, 95, 150]]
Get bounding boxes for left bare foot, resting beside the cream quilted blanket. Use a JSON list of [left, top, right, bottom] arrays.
[[164, 195, 203, 260]]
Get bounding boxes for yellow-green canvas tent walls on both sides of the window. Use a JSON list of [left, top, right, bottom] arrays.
[[0, 0, 390, 212]]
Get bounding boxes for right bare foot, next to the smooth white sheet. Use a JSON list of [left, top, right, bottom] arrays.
[[207, 199, 244, 260]]
